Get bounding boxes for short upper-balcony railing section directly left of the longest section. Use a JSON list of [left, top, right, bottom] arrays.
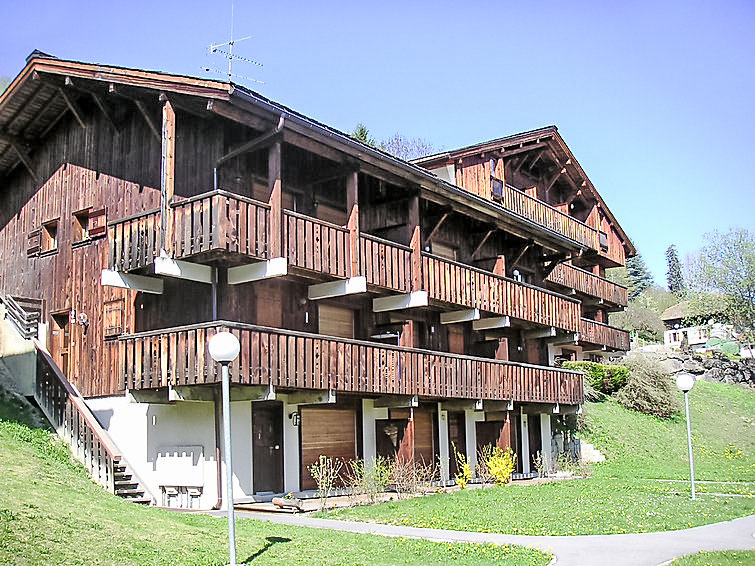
[[359, 234, 412, 293]]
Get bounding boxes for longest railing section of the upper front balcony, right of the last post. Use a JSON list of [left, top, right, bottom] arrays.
[[422, 253, 581, 332]]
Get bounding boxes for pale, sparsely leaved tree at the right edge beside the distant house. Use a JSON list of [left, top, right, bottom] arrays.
[[689, 228, 755, 341]]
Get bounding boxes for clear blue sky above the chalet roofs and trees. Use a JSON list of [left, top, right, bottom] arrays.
[[0, 0, 755, 285]]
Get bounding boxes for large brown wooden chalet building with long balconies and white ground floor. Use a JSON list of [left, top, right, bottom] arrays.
[[0, 52, 635, 508]]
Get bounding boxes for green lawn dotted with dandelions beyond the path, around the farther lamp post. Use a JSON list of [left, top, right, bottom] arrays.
[[331, 382, 755, 535]]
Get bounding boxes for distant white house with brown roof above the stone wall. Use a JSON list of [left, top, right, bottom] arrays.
[[661, 301, 734, 350]]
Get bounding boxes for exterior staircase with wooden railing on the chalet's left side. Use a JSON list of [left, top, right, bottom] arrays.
[[0, 296, 156, 505]]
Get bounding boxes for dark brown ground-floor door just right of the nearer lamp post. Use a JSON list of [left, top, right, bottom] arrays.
[[252, 401, 283, 493]]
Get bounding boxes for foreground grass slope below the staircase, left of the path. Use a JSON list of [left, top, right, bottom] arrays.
[[0, 394, 549, 566]]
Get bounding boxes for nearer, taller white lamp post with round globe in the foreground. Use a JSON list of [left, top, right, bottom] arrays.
[[209, 332, 240, 566]]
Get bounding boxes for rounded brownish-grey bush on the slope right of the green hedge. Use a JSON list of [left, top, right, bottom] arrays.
[[614, 354, 680, 418]]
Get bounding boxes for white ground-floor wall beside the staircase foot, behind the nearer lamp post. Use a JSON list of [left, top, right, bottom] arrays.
[[87, 396, 253, 509]]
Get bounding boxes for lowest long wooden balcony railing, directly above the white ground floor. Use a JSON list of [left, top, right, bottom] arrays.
[[119, 321, 583, 404]]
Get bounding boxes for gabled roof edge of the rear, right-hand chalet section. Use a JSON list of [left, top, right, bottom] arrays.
[[412, 126, 637, 257]]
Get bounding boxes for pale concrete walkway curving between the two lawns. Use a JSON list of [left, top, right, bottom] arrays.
[[232, 511, 755, 566]]
